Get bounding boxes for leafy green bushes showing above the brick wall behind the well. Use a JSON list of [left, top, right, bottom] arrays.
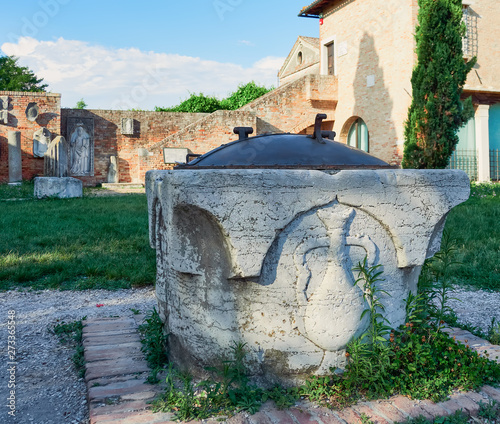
[[155, 81, 272, 113]]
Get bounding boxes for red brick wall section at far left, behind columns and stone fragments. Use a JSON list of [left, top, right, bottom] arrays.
[[0, 91, 61, 183]]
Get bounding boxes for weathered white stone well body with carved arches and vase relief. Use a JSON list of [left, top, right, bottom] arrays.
[[146, 170, 469, 383]]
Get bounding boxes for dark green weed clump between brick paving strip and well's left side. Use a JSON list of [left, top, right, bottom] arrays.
[[139, 308, 168, 384]]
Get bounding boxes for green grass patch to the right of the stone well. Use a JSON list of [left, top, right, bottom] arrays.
[[446, 183, 500, 291]]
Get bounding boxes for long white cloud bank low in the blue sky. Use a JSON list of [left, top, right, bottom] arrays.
[[1, 37, 285, 109]]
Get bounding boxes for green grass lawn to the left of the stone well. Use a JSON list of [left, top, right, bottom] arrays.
[[0, 188, 156, 290]]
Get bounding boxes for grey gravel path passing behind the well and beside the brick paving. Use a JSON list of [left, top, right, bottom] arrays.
[[0, 288, 500, 424]]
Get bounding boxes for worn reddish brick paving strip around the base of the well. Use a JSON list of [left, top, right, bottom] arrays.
[[83, 315, 500, 424]]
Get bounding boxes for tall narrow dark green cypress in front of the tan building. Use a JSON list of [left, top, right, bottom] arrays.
[[402, 0, 476, 169]]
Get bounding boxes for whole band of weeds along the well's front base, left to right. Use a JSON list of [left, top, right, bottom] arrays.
[[147, 236, 500, 424]]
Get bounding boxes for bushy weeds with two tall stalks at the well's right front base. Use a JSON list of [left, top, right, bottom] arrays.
[[301, 250, 500, 407]]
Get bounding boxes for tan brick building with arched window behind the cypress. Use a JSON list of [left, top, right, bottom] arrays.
[[279, 0, 500, 180]]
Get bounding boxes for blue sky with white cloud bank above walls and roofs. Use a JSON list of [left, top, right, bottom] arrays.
[[0, 0, 318, 109]]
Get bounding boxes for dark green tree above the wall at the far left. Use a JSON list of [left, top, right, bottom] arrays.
[[0, 56, 47, 91]]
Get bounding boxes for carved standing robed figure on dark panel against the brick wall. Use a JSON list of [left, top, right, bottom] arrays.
[[67, 118, 94, 176]]
